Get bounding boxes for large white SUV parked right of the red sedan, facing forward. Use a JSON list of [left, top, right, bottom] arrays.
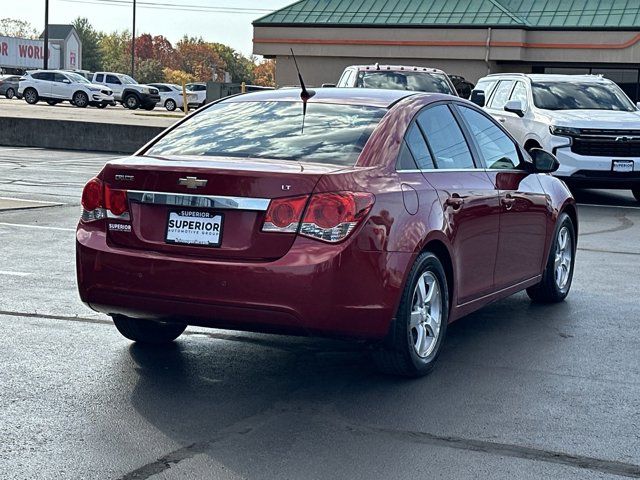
[[471, 74, 640, 201]]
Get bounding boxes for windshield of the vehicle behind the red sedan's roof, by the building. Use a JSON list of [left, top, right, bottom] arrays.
[[356, 71, 456, 95]]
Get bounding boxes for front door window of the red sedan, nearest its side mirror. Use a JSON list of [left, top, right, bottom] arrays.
[[457, 105, 520, 170]]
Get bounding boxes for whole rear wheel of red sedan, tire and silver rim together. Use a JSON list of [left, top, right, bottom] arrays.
[[374, 252, 449, 377]]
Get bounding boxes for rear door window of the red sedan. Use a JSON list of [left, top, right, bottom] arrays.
[[418, 105, 474, 168]]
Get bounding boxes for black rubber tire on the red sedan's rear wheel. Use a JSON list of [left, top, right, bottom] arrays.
[[373, 252, 449, 377]]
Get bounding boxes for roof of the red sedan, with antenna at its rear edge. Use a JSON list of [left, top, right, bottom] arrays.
[[223, 87, 423, 108]]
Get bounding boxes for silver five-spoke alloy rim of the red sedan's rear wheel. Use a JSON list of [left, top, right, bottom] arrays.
[[409, 271, 443, 358]]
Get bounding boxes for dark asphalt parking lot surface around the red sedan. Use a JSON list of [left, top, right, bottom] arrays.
[[0, 148, 640, 480]]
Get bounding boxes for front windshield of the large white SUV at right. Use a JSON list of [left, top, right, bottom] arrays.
[[531, 82, 636, 112]]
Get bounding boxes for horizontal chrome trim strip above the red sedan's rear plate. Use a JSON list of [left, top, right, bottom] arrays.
[[127, 190, 271, 212]]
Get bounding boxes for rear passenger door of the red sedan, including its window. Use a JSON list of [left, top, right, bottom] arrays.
[[417, 103, 500, 305]]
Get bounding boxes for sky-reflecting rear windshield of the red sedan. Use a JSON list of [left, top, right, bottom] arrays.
[[146, 102, 386, 165]]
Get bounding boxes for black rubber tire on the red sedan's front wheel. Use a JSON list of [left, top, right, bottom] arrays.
[[527, 213, 577, 303]]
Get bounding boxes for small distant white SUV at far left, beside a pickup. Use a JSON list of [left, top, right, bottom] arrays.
[[18, 70, 116, 108]]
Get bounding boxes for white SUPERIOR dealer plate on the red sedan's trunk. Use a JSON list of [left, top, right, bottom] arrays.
[[166, 210, 222, 247]]
